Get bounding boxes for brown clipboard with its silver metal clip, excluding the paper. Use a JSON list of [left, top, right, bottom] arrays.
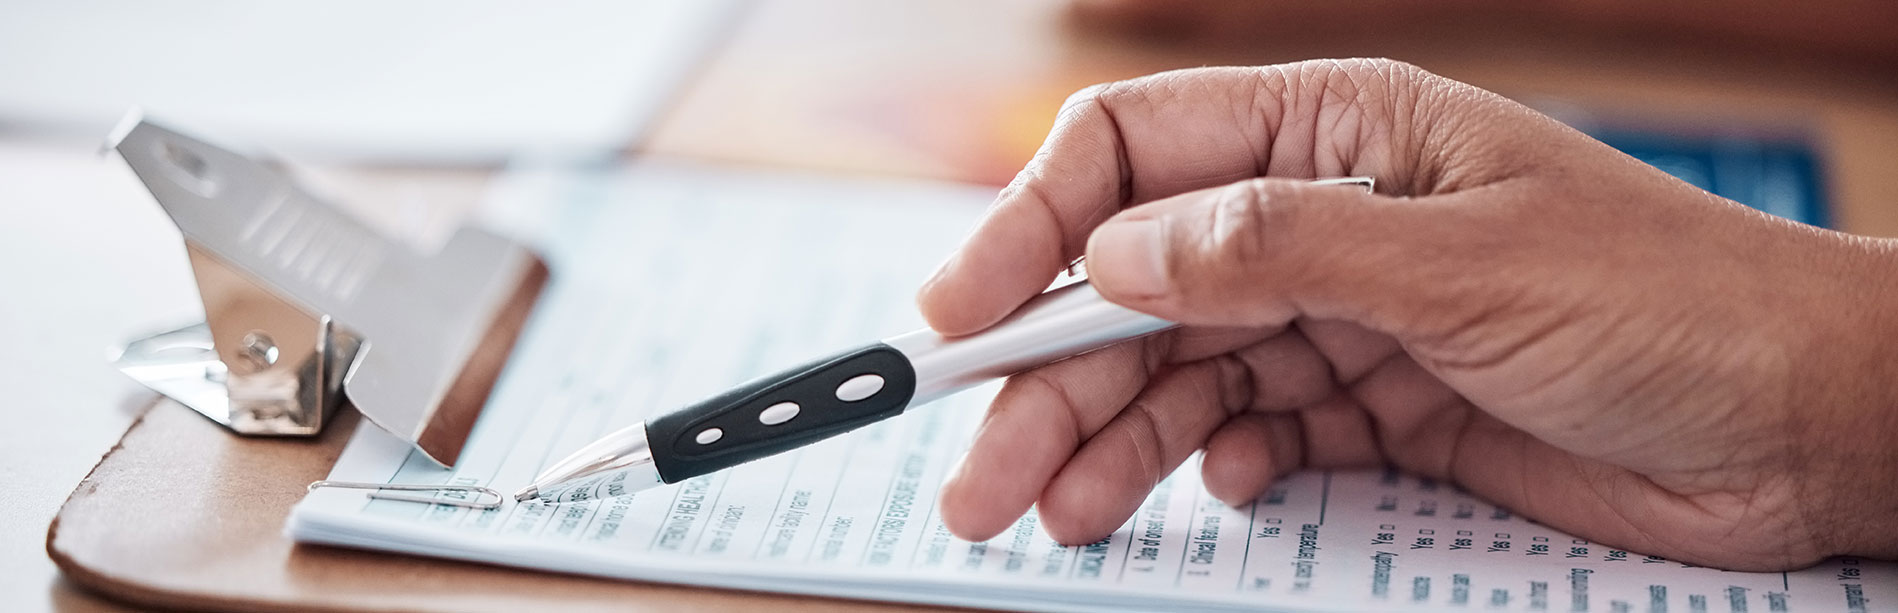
[[46, 114, 956, 611]]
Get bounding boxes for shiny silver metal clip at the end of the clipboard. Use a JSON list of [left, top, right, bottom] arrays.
[[112, 112, 547, 465]]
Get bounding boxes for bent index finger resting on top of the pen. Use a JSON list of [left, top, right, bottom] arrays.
[[917, 61, 1416, 336]]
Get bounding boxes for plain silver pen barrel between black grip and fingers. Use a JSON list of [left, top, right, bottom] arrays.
[[883, 283, 1175, 406]]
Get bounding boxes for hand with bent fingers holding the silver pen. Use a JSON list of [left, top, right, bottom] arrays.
[[919, 61, 1898, 569]]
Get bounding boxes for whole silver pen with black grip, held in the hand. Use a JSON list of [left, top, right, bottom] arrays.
[[514, 176, 1372, 501]]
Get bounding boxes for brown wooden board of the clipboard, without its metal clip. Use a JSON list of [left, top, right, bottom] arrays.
[[46, 400, 947, 613]]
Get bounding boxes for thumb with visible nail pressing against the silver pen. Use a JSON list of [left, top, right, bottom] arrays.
[[1088, 178, 1501, 340]]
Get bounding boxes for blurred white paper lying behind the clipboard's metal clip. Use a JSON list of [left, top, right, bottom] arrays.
[[0, 0, 742, 163]]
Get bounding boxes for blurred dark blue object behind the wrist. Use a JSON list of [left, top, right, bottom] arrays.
[[1591, 129, 1832, 228]]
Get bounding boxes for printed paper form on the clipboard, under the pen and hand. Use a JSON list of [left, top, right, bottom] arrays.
[[288, 165, 1898, 611]]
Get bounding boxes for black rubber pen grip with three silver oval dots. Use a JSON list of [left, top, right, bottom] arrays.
[[645, 344, 917, 484]]
